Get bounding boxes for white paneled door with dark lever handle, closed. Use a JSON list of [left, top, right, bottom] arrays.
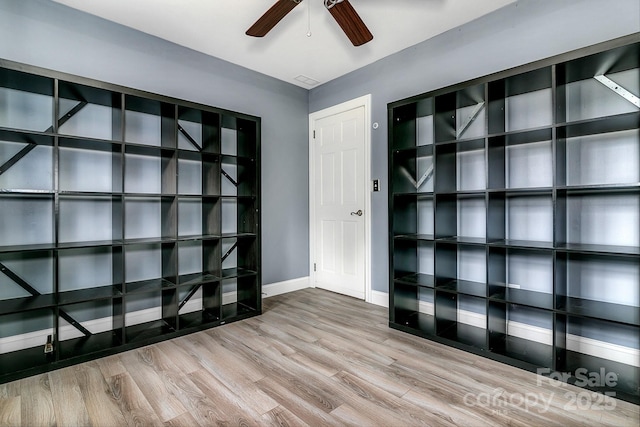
[[311, 106, 369, 299]]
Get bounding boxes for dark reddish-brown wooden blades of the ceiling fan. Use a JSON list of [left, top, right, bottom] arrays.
[[246, 0, 373, 46]]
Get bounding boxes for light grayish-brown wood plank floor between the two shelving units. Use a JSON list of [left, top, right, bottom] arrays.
[[0, 289, 639, 427]]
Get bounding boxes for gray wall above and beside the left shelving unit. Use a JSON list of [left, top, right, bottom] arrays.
[[0, 0, 309, 284]]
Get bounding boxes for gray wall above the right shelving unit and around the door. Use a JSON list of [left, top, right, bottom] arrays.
[[309, 0, 640, 292]]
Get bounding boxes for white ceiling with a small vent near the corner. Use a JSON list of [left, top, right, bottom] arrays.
[[54, 0, 515, 89]]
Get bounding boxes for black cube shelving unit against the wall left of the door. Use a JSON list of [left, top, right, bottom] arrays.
[[0, 60, 262, 382]]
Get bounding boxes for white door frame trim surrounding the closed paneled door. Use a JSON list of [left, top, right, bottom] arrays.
[[309, 94, 372, 302]]
